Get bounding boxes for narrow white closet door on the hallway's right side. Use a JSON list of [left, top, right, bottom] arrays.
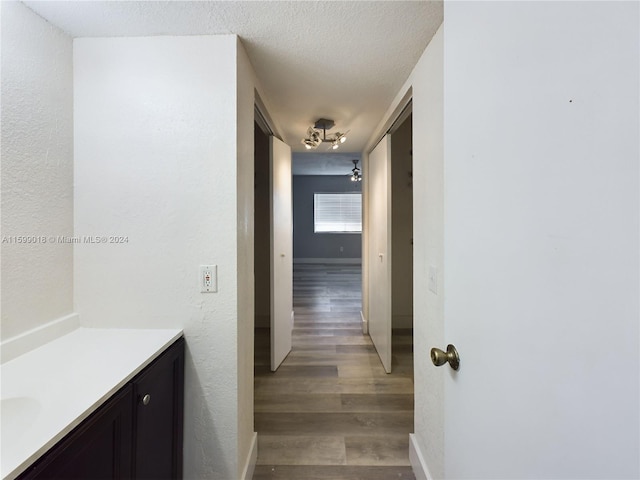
[[366, 135, 391, 373]]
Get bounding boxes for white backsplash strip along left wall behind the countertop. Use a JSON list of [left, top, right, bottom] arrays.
[[0, 313, 80, 363]]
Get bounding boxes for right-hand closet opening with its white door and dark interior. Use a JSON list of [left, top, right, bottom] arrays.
[[364, 105, 413, 373]]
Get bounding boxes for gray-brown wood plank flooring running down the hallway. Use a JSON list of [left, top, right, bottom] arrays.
[[253, 265, 415, 480]]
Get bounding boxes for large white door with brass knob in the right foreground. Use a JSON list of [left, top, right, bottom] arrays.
[[442, 2, 640, 479]]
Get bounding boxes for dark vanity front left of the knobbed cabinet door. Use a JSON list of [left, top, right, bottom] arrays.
[[20, 385, 133, 480]]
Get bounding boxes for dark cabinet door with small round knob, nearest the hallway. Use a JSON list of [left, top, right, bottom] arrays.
[[133, 339, 184, 480]]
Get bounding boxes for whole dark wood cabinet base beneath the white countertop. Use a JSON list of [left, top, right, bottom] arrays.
[[18, 338, 184, 480]]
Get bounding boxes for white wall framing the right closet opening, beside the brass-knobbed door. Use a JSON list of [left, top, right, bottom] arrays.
[[363, 26, 445, 479]]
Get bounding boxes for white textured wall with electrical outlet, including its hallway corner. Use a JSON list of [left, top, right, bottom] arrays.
[[74, 36, 253, 480]]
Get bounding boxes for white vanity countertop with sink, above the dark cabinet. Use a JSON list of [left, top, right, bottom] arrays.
[[0, 328, 182, 480]]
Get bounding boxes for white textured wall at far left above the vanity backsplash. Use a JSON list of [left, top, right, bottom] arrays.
[[0, 1, 73, 340]]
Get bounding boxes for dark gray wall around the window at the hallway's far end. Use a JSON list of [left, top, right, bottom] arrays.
[[293, 171, 362, 263]]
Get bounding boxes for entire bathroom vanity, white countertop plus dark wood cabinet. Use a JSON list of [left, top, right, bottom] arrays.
[[2, 328, 184, 480]]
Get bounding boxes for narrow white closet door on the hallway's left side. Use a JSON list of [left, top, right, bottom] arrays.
[[269, 136, 293, 372]]
